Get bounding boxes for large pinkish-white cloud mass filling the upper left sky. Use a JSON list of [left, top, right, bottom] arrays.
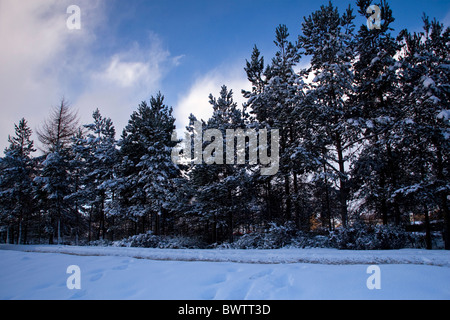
[[0, 0, 182, 152]]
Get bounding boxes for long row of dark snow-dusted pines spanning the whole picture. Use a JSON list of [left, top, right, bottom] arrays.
[[0, 0, 450, 249]]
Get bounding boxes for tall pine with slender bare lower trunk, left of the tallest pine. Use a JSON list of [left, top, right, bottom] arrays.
[[299, 2, 357, 226]]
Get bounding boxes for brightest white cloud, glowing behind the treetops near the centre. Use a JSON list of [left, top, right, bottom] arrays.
[[174, 63, 251, 131]]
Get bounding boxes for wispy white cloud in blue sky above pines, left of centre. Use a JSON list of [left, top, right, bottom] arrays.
[[74, 33, 182, 137]]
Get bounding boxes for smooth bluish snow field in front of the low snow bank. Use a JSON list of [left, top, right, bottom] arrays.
[[0, 246, 450, 300]]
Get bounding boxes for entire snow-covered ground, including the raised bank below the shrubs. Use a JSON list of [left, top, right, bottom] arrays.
[[0, 245, 450, 300]]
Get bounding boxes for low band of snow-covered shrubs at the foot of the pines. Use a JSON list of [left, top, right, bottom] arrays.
[[85, 223, 436, 250]]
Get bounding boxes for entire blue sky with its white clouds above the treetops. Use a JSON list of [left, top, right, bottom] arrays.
[[0, 0, 450, 150]]
